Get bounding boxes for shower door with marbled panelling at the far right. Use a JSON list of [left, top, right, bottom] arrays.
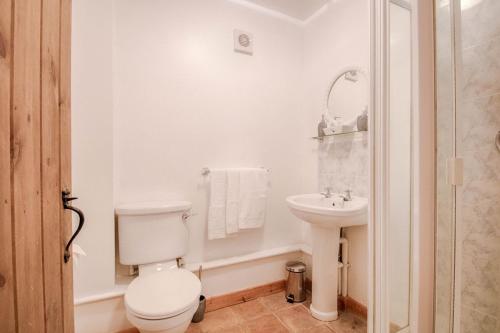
[[435, 0, 500, 333]]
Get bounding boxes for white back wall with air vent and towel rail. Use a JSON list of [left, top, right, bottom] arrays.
[[113, 0, 315, 262]]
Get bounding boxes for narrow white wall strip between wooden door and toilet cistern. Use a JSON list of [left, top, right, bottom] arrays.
[[71, 0, 115, 298]]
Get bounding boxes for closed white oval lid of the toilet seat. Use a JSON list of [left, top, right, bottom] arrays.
[[125, 269, 201, 319]]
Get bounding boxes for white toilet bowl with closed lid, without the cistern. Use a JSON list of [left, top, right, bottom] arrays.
[[125, 268, 201, 333]]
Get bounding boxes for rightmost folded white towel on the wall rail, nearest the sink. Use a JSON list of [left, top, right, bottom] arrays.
[[238, 168, 268, 229]]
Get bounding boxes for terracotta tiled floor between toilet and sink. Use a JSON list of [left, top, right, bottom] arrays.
[[188, 292, 366, 333]]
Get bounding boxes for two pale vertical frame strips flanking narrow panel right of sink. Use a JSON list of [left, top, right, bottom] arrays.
[[368, 0, 436, 333]]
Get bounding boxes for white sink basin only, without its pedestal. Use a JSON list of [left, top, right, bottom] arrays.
[[286, 193, 368, 228]]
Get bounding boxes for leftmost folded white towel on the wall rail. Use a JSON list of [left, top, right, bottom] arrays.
[[208, 169, 227, 239]]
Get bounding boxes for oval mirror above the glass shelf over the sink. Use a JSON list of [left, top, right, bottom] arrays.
[[326, 68, 368, 132]]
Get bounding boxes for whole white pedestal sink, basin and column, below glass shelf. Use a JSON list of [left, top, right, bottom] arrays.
[[286, 193, 368, 321]]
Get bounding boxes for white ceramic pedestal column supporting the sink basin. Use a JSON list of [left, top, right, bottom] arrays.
[[310, 224, 340, 321]]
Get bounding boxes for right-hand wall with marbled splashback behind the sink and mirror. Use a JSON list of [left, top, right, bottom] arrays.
[[298, 0, 370, 305]]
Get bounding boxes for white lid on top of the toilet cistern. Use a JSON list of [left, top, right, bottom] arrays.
[[115, 200, 192, 215]]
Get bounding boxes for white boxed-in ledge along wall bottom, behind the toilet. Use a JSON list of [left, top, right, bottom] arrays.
[[75, 245, 303, 333]]
